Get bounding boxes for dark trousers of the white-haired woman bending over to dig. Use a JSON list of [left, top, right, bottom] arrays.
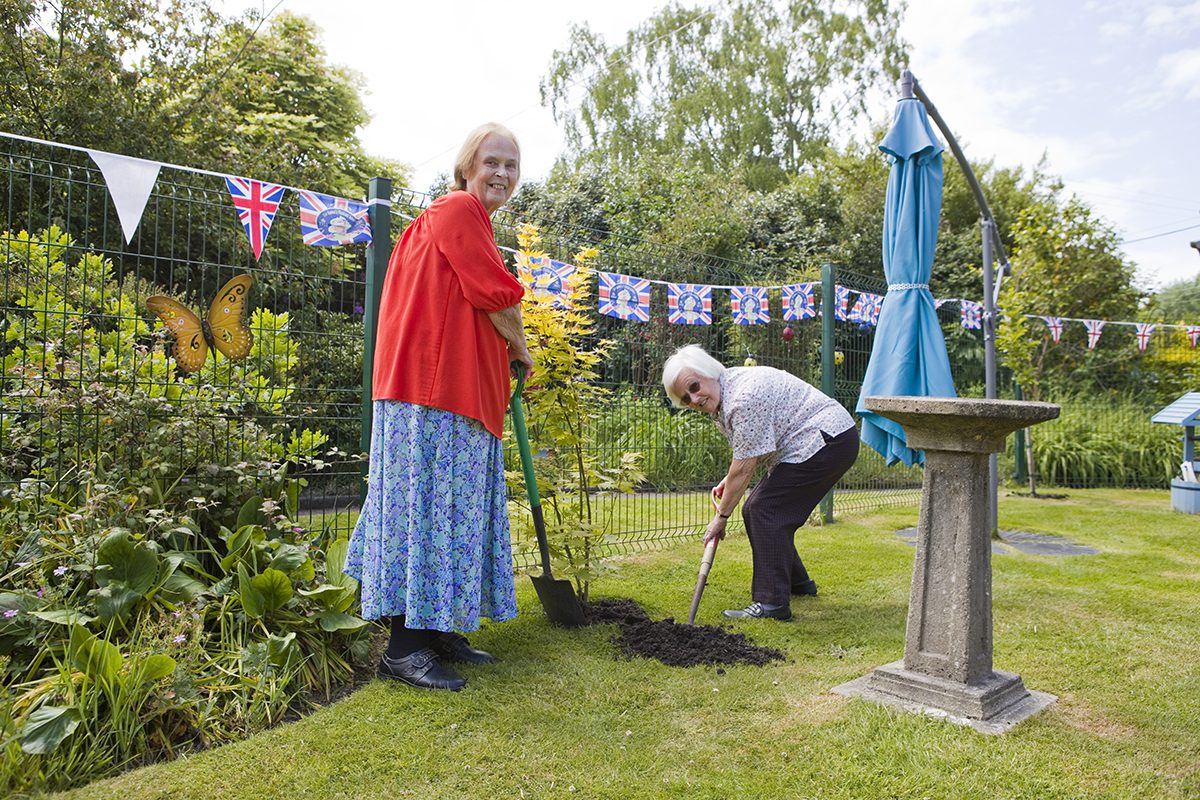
[[742, 428, 858, 606]]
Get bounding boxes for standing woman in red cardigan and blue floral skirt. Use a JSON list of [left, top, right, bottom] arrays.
[[346, 124, 533, 691]]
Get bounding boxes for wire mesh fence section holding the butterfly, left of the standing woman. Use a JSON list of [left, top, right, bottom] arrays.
[[0, 139, 364, 551]]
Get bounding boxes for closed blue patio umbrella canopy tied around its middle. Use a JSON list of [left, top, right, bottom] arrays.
[[856, 90, 956, 467]]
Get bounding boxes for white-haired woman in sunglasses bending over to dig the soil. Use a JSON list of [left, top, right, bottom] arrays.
[[662, 344, 858, 620]]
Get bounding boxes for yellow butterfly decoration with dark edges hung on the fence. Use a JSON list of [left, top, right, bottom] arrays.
[[146, 275, 254, 373]]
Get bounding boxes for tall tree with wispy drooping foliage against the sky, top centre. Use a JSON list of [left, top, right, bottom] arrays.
[[542, 0, 905, 188]]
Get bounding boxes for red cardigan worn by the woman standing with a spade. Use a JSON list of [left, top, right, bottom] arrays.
[[373, 191, 524, 438]]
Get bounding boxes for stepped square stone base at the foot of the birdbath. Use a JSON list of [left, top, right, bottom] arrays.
[[833, 661, 1058, 733]]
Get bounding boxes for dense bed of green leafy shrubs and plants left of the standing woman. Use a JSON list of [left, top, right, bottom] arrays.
[[0, 229, 367, 793]]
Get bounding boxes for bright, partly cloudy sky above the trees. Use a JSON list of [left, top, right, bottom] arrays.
[[226, 0, 1200, 289]]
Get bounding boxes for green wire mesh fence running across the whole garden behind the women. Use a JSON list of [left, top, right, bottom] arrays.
[[0, 139, 1200, 566]]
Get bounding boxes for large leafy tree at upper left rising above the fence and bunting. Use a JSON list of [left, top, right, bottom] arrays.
[[0, 0, 403, 194]]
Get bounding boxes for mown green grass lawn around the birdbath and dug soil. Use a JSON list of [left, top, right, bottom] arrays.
[[51, 491, 1200, 800]]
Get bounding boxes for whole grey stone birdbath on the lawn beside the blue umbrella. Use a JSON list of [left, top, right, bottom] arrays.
[[833, 397, 1058, 733]]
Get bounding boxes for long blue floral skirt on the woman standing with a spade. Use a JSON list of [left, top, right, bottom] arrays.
[[344, 401, 517, 633]]
